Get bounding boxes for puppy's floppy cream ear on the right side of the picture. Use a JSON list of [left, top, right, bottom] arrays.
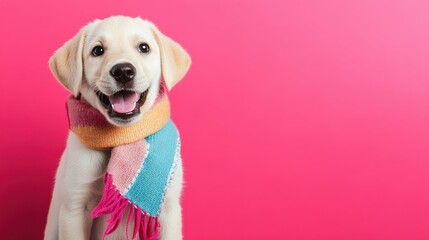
[[150, 24, 191, 91]]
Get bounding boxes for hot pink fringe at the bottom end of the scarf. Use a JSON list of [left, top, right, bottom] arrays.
[[91, 173, 160, 240]]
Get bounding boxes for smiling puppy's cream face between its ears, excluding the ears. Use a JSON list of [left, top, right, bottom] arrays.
[[81, 18, 161, 124]]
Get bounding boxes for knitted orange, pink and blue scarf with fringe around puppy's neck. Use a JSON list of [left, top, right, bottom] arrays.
[[67, 89, 180, 240]]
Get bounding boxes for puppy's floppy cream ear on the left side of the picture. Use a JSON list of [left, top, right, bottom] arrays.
[[49, 28, 86, 96]]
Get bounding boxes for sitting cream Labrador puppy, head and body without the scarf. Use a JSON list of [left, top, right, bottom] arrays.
[[45, 16, 191, 240]]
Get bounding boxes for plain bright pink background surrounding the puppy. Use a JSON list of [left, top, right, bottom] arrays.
[[0, 0, 429, 240]]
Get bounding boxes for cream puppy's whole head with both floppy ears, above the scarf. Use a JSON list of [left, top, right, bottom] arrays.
[[49, 16, 191, 126]]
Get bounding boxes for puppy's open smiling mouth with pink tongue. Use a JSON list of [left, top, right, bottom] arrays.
[[96, 90, 148, 120]]
